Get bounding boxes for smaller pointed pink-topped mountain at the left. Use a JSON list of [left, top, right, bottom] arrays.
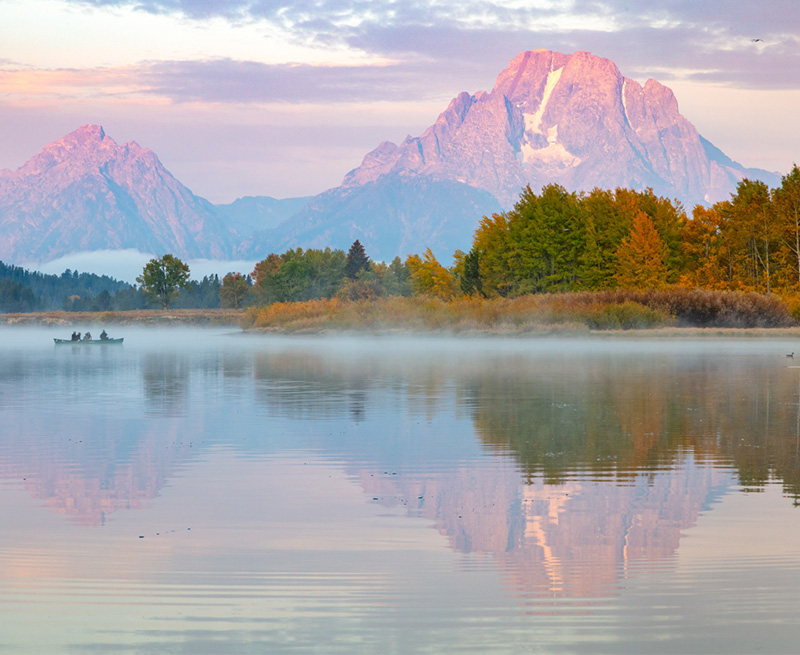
[[0, 125, 240, 261]]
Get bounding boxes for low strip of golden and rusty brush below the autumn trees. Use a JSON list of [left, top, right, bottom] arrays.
[[241, 288, 797, 334]]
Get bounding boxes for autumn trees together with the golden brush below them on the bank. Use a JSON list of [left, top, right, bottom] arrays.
[[244, 166, 800, 332]]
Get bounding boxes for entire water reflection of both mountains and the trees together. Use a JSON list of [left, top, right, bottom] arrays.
[[0, 342, 800, 568]]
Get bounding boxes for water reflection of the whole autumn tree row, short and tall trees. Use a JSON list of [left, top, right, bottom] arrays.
[[248, 351, 800, 496]]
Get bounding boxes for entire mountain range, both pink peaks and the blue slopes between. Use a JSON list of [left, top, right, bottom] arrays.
[[0, 50, 779, 263]]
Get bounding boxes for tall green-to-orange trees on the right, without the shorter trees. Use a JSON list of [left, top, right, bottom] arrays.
[[456, 165, 800, 297]]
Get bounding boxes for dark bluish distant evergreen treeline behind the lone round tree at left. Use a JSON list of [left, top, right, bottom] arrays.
[[0, 261, 222, 313]]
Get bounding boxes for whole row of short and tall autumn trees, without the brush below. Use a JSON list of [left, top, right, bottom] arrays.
[[244, 166, 800, 305]]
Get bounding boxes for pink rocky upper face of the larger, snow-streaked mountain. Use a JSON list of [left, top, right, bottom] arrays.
[[343, 50, 777, 207]]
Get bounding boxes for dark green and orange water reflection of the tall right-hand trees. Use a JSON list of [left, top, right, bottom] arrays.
[[464, 356, 800, 496]]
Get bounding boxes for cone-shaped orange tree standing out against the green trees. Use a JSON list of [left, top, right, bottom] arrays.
[[614, 211, 667, 289]]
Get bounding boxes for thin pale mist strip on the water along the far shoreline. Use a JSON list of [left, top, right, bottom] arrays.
[[6, 323, 800, 366]]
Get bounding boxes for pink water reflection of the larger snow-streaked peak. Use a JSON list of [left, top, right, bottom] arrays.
[[359, 460, 732, 601]]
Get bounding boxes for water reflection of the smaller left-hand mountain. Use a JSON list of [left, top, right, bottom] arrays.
[[0, 349, 203, 525]]
